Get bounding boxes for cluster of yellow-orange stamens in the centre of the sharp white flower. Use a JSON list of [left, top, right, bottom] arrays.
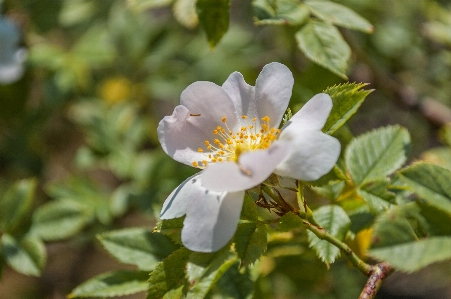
[[192, 115, 280, 168]]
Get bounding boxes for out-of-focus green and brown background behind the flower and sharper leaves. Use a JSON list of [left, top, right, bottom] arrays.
[[0, 0, 451, 299]]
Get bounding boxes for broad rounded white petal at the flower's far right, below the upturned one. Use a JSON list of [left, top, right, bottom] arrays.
[[275, 130, 340, 181]]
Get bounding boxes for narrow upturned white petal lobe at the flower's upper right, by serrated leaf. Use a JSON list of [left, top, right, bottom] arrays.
[[281, 93, 332, 135]]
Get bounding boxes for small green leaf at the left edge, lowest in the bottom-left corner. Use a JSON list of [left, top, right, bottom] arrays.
[[1, 234, 46, 276]]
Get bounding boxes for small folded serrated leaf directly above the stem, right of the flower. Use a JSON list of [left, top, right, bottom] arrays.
[[308, 205, 351, 264]]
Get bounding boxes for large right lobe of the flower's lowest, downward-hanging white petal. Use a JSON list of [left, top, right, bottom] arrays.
[[182, 189, 244, 252]]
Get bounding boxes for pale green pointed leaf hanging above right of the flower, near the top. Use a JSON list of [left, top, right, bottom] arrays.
[[295, 20, 351, 79]]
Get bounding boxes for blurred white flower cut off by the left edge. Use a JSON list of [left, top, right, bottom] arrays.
[[0, 16, 26, 84]]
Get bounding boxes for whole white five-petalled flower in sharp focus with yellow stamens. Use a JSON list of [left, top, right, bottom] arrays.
[[158, 62, 340, 252]]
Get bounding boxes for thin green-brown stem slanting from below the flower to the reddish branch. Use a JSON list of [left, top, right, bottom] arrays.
[[303, 221, 373, 276]]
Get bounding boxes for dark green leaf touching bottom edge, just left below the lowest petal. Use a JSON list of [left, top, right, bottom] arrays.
[[147, 248, 191, 299]]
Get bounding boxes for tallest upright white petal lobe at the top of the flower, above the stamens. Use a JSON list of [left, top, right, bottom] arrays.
[[255, 62, 294, 127]]
